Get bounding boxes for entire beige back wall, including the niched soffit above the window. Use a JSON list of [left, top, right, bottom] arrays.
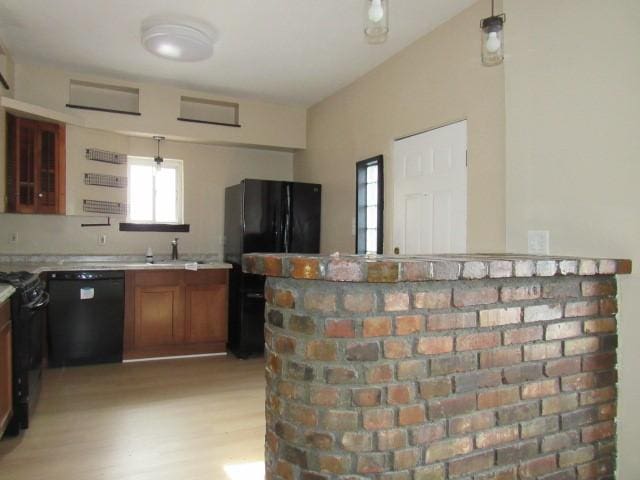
[[0, 54, 296, 254]]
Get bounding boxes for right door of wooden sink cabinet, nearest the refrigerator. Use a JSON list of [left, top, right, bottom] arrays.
[[186, 285, 227, 343]]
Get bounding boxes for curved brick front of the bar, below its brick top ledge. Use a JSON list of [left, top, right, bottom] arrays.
[[265, 272, 626, 480]]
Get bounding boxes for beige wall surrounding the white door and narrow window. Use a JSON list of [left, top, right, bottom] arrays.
[[294, 0, 505, 252]]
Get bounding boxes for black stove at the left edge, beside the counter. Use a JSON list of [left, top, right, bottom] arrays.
[[0, 272, 49, 435]]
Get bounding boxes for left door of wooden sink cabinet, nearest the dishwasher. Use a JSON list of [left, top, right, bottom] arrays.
[[134, 286, 184, 347]]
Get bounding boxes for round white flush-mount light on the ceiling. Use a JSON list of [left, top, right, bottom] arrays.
[[142, 20, 214, 62]]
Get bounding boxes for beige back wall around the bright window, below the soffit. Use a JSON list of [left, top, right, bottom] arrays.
[[0, 127, 293, 255]]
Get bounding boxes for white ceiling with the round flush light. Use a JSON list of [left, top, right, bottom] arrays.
[[0, 0, 480, 106]]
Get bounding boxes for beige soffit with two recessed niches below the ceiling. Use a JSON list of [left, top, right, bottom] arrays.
[[15, 64, 306, 150]]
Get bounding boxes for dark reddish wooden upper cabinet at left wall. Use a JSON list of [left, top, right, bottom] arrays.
[[7, 114, 66, 214]]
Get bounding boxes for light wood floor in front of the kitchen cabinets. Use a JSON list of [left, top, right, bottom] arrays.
[[0, 357, 265, 480]]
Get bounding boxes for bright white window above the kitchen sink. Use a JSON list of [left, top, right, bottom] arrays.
[[127, 157, 182, 223]]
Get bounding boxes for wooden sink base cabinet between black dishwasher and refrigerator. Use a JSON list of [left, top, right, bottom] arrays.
[[124, 270, 228, 360]]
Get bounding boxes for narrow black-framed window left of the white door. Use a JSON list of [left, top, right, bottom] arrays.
[[355, 155, 384, 255]]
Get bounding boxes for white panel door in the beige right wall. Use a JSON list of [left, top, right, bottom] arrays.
[[393, 120, 467, 255]]
